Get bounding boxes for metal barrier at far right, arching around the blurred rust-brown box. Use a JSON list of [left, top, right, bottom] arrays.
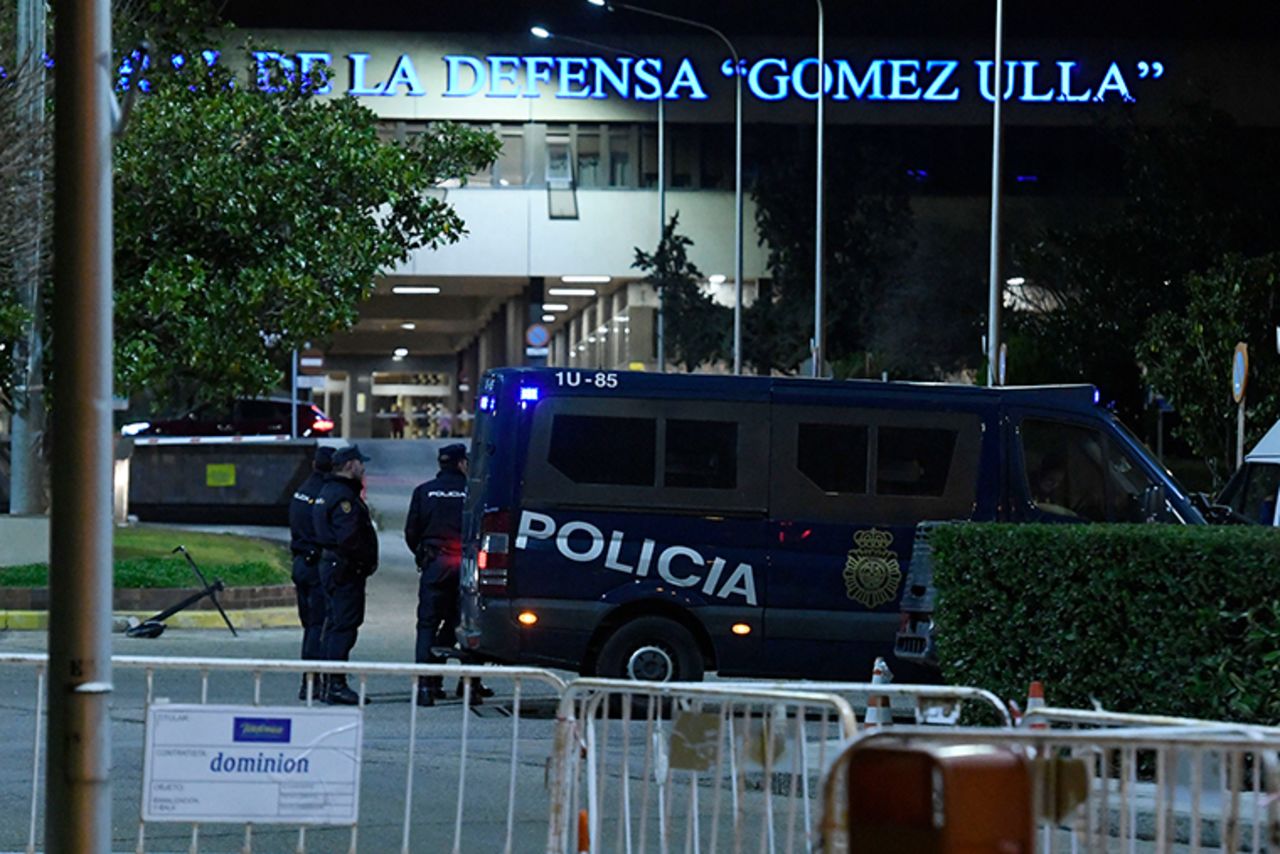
[[822, 722, 1280, 854]]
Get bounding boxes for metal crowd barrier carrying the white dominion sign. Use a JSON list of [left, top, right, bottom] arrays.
[[0, 653, 564, 854]]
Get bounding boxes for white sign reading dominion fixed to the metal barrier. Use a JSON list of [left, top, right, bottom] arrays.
[[142, 704, 362, 825]]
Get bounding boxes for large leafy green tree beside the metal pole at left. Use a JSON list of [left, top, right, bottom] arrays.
[[115, 50, 499, 405]]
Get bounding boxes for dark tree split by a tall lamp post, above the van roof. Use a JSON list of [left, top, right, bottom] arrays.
[[742, 133, 911, 374]]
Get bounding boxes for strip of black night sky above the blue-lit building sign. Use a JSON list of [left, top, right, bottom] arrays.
[[225, 0, 1280, 42]]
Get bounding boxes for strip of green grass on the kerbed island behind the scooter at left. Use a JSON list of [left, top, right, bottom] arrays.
[[0, 525, 291, 588]]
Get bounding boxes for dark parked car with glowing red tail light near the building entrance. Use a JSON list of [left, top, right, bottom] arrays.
[[120, 397, 333, 438]]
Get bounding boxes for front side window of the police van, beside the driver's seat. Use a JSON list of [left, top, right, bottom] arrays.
[[1021, 419, 1107, 522]]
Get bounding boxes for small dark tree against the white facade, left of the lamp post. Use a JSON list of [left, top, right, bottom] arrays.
[[631, 213, 730, 373]]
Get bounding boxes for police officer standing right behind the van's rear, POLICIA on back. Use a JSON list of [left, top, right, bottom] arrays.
[[404, 442, 493, 705]]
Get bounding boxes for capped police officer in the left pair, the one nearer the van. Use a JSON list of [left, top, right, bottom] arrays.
[[312, 444, 378, 705]]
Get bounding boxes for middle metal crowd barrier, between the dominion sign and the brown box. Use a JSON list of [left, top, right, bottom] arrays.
[[547, 679, 858, 854]]
